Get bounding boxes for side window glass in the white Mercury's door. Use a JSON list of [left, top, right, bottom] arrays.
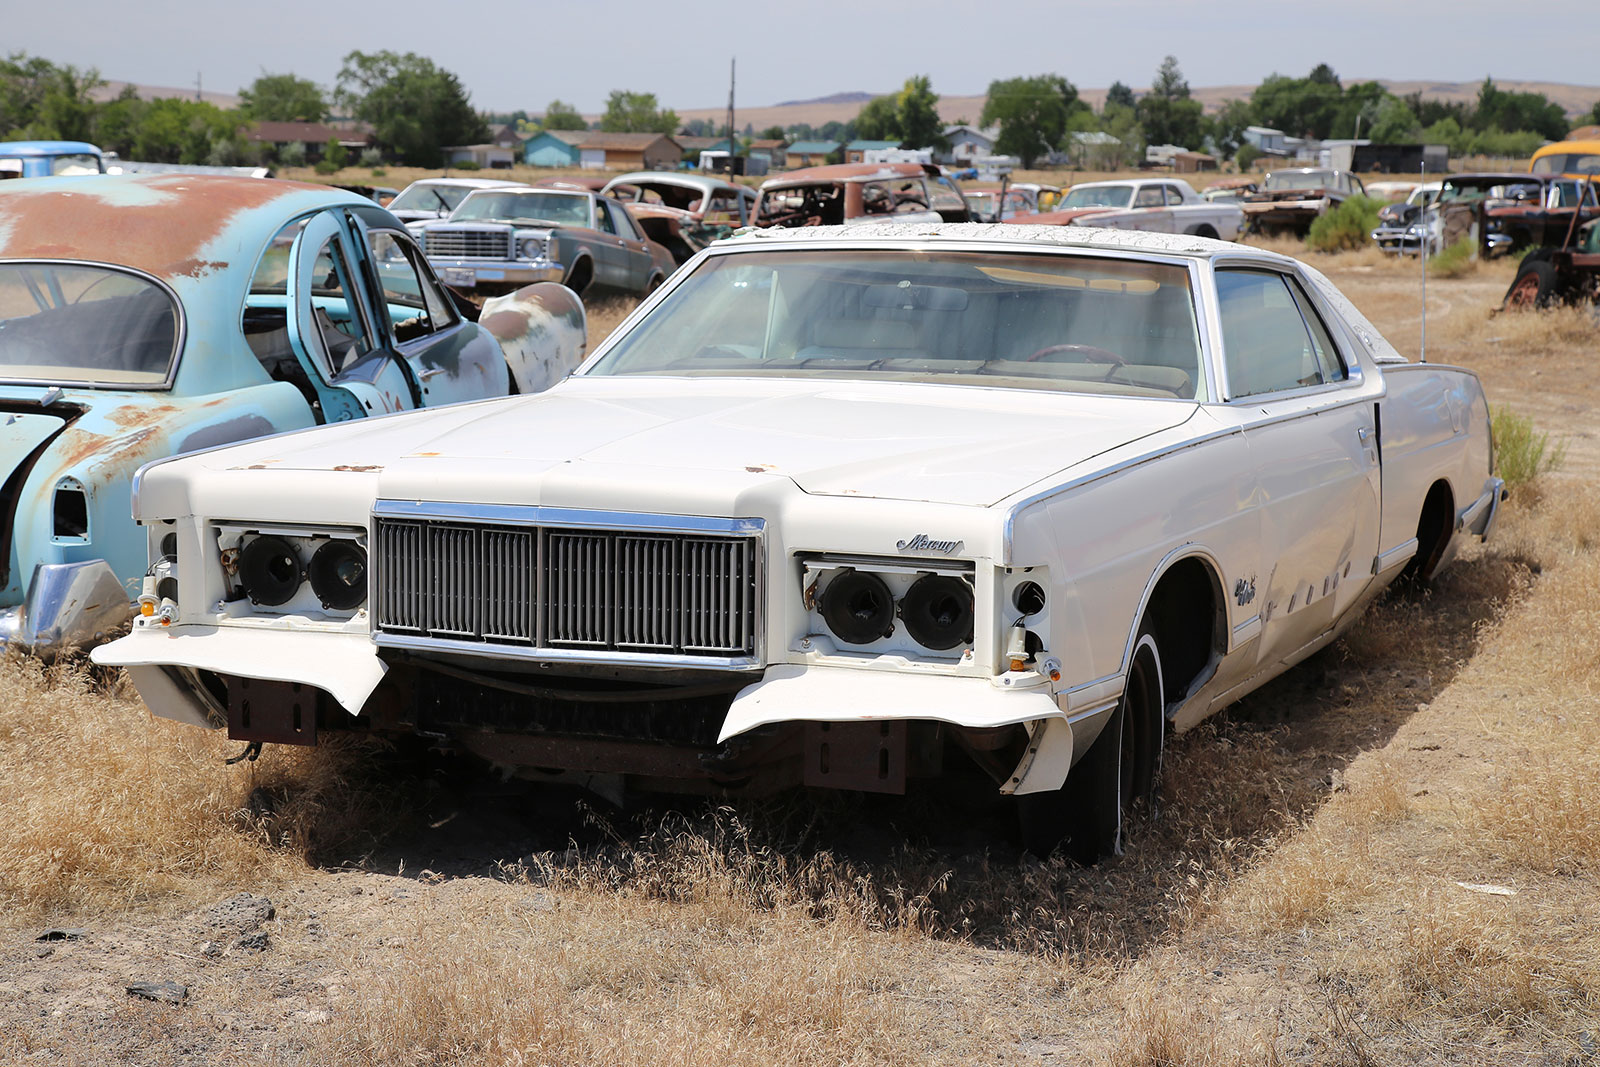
[[1216, 270, 1346, 397]]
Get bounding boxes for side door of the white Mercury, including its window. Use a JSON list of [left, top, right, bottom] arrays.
[[1216, 267, 1381, 665]]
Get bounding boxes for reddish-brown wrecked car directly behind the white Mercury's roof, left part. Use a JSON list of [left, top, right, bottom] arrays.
[[752, 163, 971, 229]]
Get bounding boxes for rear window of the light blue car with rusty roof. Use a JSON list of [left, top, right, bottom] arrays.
[[0, 262, 178, 386]]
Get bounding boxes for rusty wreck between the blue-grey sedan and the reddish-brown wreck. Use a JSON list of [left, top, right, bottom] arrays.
[[600, 171, 755, 266]]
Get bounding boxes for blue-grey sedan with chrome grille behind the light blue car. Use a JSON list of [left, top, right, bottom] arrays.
[[411, 184, 677, 296]]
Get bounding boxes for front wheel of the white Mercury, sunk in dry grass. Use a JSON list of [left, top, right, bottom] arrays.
[[1018, 624, 1165, 864]]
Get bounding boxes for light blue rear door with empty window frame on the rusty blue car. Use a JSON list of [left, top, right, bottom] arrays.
[[288, 211, 416, 422]]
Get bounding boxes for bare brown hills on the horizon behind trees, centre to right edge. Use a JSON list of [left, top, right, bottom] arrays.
[[677, 78, 1600, 130]]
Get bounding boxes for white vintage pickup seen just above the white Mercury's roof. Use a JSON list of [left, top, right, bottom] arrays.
[[1006, 178, 1245, 242]]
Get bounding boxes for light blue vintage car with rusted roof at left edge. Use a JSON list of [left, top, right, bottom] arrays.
[[0, 174, 586, 654]]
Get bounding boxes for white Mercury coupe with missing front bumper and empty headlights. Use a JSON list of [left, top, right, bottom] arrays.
[[94, 224, 1502, 859]]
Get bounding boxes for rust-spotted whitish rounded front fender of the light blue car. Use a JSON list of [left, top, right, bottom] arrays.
[[478, 282, 589, 394]]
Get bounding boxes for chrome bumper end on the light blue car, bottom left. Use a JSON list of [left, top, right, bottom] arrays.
[[0, 560, 133, 657]]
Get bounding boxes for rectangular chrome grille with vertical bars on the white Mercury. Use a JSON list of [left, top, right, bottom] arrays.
[[373, 517, 758, 659]]
